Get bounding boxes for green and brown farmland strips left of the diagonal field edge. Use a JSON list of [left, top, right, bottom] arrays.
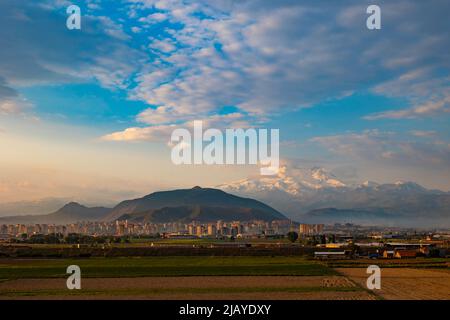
[[0, 256, 375, 299]]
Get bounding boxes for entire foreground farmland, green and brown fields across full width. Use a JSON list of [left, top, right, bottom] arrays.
[[0, 256, 450, 300]]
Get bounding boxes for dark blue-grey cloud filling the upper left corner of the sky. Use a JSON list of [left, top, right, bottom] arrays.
[[0, 1, 143, 95]]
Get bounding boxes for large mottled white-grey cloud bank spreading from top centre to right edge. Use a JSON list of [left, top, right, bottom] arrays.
[[122, 0, 450, 124]]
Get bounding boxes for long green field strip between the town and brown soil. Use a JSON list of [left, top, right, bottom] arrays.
[[0, 256, 336, 279]]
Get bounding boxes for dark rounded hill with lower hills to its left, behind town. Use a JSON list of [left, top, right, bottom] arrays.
[[0, 187, 287, 224]]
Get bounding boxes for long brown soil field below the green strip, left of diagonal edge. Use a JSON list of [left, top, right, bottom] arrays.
[[0, 276, 376, 300]]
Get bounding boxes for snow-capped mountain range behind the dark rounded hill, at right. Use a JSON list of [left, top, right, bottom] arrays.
[[218, 167, 450, 227]]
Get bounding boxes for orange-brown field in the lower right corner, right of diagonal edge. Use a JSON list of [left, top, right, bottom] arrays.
[[336, 268, 450, 300]]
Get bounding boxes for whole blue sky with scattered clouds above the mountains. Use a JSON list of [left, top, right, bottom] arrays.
[[0, 0, 450, 203]]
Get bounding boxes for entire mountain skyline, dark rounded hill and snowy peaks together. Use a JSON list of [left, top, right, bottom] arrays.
[[0, 167, 450, 227]]
